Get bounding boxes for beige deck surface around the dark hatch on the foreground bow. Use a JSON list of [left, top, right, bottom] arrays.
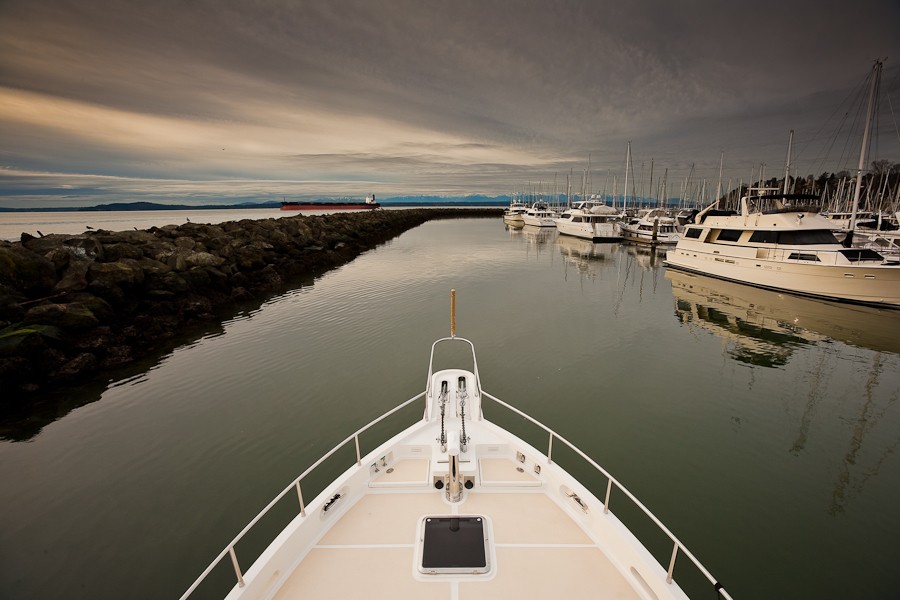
[[275, 459, 640, 600]]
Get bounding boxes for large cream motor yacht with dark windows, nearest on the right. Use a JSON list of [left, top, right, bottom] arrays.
[[666, 191, 900, 308]]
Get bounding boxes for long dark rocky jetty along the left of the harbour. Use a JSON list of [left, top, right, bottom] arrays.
[[0, 209, 501, 400]]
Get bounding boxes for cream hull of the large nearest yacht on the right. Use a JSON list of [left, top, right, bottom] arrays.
[[666, 244, 900, 308]]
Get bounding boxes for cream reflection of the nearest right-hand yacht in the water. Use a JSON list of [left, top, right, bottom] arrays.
[[666, 269, 900, 367]]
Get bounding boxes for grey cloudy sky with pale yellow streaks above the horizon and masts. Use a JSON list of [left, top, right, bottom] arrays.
[[0, 0, 900, 209]]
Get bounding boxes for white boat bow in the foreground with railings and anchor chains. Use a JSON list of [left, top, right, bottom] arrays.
[[182, 293, 731, 600]]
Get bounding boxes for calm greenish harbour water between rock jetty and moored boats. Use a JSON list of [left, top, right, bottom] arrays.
[[0, 219, 900, 599]]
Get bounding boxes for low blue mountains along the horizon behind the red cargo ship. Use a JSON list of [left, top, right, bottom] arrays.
[[0, 196, 509, 212]]
